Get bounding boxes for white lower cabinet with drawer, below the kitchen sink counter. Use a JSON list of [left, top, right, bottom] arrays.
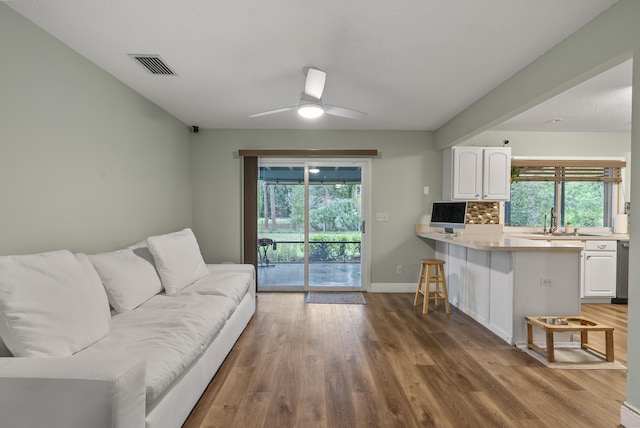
[[582, 241, 617, 298]]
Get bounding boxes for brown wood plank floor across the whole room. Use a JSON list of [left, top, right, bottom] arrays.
[[184, 293, 627, 428]]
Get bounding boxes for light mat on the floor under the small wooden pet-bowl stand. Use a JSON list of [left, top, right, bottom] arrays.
[[517, 343, 627, 370]]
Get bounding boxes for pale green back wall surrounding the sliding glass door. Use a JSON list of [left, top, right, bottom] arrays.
[[191, 129, 442, 283]]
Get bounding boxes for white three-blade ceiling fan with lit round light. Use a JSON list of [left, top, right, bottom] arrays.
[[249, 67, 367, 119]]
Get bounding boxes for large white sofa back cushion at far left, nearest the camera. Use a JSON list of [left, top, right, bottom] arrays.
[[0, 250, 111, 357]]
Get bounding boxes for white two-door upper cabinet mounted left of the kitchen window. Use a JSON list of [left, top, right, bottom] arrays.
[[442, 147, 511, 201]]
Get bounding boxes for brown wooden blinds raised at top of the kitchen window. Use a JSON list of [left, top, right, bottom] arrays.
[[511, 159, 626, 183]]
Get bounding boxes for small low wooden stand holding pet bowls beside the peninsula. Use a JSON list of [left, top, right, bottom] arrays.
[[525, 315, 613, 363]]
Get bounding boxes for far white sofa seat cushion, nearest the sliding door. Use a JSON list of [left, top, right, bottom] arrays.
[[182, 266, 253, 304]]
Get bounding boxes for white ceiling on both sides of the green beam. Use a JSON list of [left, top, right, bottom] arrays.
[[6, 0, 631, 130]]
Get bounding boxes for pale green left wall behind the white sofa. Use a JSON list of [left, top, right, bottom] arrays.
[[0, 4, 192, 255]]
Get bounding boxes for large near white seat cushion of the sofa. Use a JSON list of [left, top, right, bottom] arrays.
[[72, 294, 236, 404]]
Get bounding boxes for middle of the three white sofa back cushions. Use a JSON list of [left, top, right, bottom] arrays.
[[89, 247, 162, 312]]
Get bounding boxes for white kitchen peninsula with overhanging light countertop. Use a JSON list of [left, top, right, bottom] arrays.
[[416, 229, 583, 345]]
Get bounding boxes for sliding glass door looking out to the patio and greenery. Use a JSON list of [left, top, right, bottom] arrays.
[[257, 159, 368, 291]]
